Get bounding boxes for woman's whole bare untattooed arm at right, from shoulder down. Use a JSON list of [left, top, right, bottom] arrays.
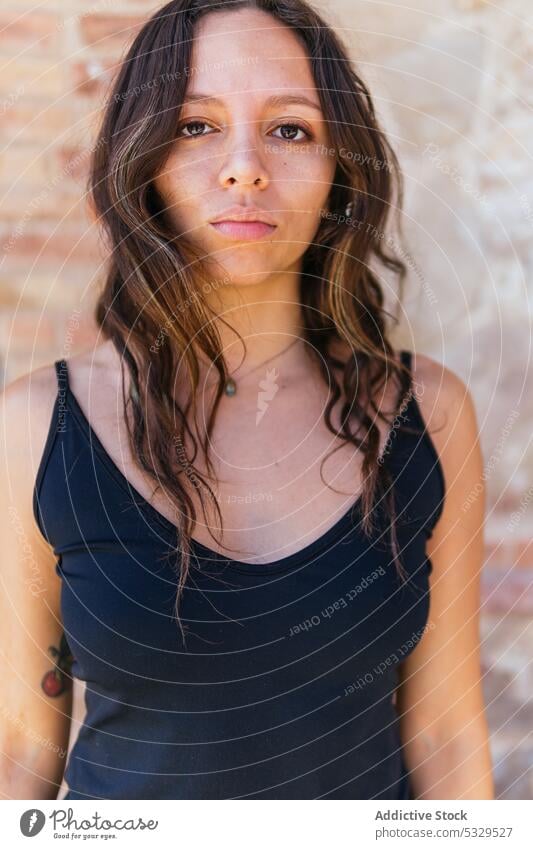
[[397, 355, 494, 799]]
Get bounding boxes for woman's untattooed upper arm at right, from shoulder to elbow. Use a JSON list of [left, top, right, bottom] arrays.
[[397, 355, 485, 745]]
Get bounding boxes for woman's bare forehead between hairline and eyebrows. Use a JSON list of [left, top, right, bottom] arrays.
[[187, 9, 319, 103]]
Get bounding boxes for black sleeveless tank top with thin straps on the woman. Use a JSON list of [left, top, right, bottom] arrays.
[[33, 351, 444, 800]]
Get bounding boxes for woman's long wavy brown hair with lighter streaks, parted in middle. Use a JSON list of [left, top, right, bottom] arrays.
[[88, 0, 418, 633]]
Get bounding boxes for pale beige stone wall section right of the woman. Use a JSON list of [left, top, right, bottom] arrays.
[[319, 0, 533, 799]]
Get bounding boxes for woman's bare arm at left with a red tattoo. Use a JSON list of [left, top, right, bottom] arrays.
[[0, 368, 72, 799]]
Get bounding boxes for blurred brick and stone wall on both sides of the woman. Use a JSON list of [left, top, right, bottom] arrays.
[[0, 0, 533, 799]]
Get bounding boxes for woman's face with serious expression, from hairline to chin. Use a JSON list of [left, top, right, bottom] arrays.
[[155, 9, 335, 286]]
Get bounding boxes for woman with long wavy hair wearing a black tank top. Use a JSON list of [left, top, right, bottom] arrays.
[[1, 0, 493, 799]]
